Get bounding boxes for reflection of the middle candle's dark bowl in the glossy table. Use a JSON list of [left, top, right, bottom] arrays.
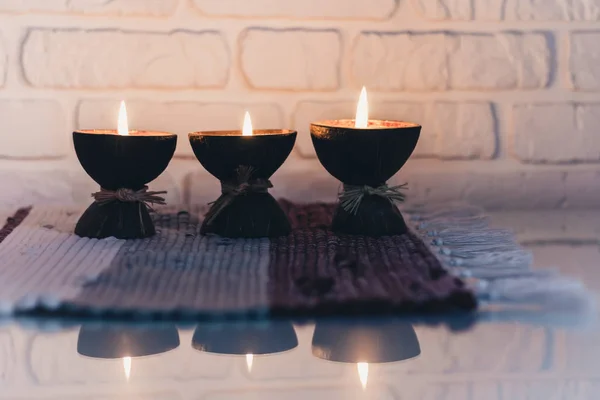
[[192, 321, 298, 355]]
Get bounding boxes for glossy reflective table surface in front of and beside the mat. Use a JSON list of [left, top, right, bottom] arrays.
[[0, 211, 600, 400]]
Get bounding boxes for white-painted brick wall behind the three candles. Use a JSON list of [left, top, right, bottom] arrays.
[[0, 0, 600, 208]]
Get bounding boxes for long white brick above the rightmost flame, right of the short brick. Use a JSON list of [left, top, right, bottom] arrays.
[[351, 32, 551, 91]]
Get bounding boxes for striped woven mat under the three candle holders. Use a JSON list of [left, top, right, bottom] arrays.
[[0, 201, 584, 317]]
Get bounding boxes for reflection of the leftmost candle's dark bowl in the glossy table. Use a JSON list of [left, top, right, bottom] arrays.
[[77, 325, 179, 359]]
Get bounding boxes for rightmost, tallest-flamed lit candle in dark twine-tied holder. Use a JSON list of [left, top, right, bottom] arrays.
[[310, 88, 421, 236]]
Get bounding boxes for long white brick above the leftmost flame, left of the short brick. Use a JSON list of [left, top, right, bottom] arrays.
[[22, 29, 230, 89]]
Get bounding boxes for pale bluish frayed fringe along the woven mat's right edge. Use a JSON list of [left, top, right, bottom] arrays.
[[404, 203, 593, 310]]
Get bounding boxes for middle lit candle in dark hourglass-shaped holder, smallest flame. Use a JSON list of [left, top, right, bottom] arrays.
[[189, 113, 296, 238]]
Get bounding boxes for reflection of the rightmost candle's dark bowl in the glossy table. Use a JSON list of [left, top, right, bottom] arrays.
[[312, 319, 421, 364]]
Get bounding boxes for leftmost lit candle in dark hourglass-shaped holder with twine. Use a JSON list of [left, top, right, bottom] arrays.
[[73, 102, 177, 239]]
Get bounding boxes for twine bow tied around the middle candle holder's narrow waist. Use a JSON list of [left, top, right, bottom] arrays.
[[205, 165, 273, 225]]
